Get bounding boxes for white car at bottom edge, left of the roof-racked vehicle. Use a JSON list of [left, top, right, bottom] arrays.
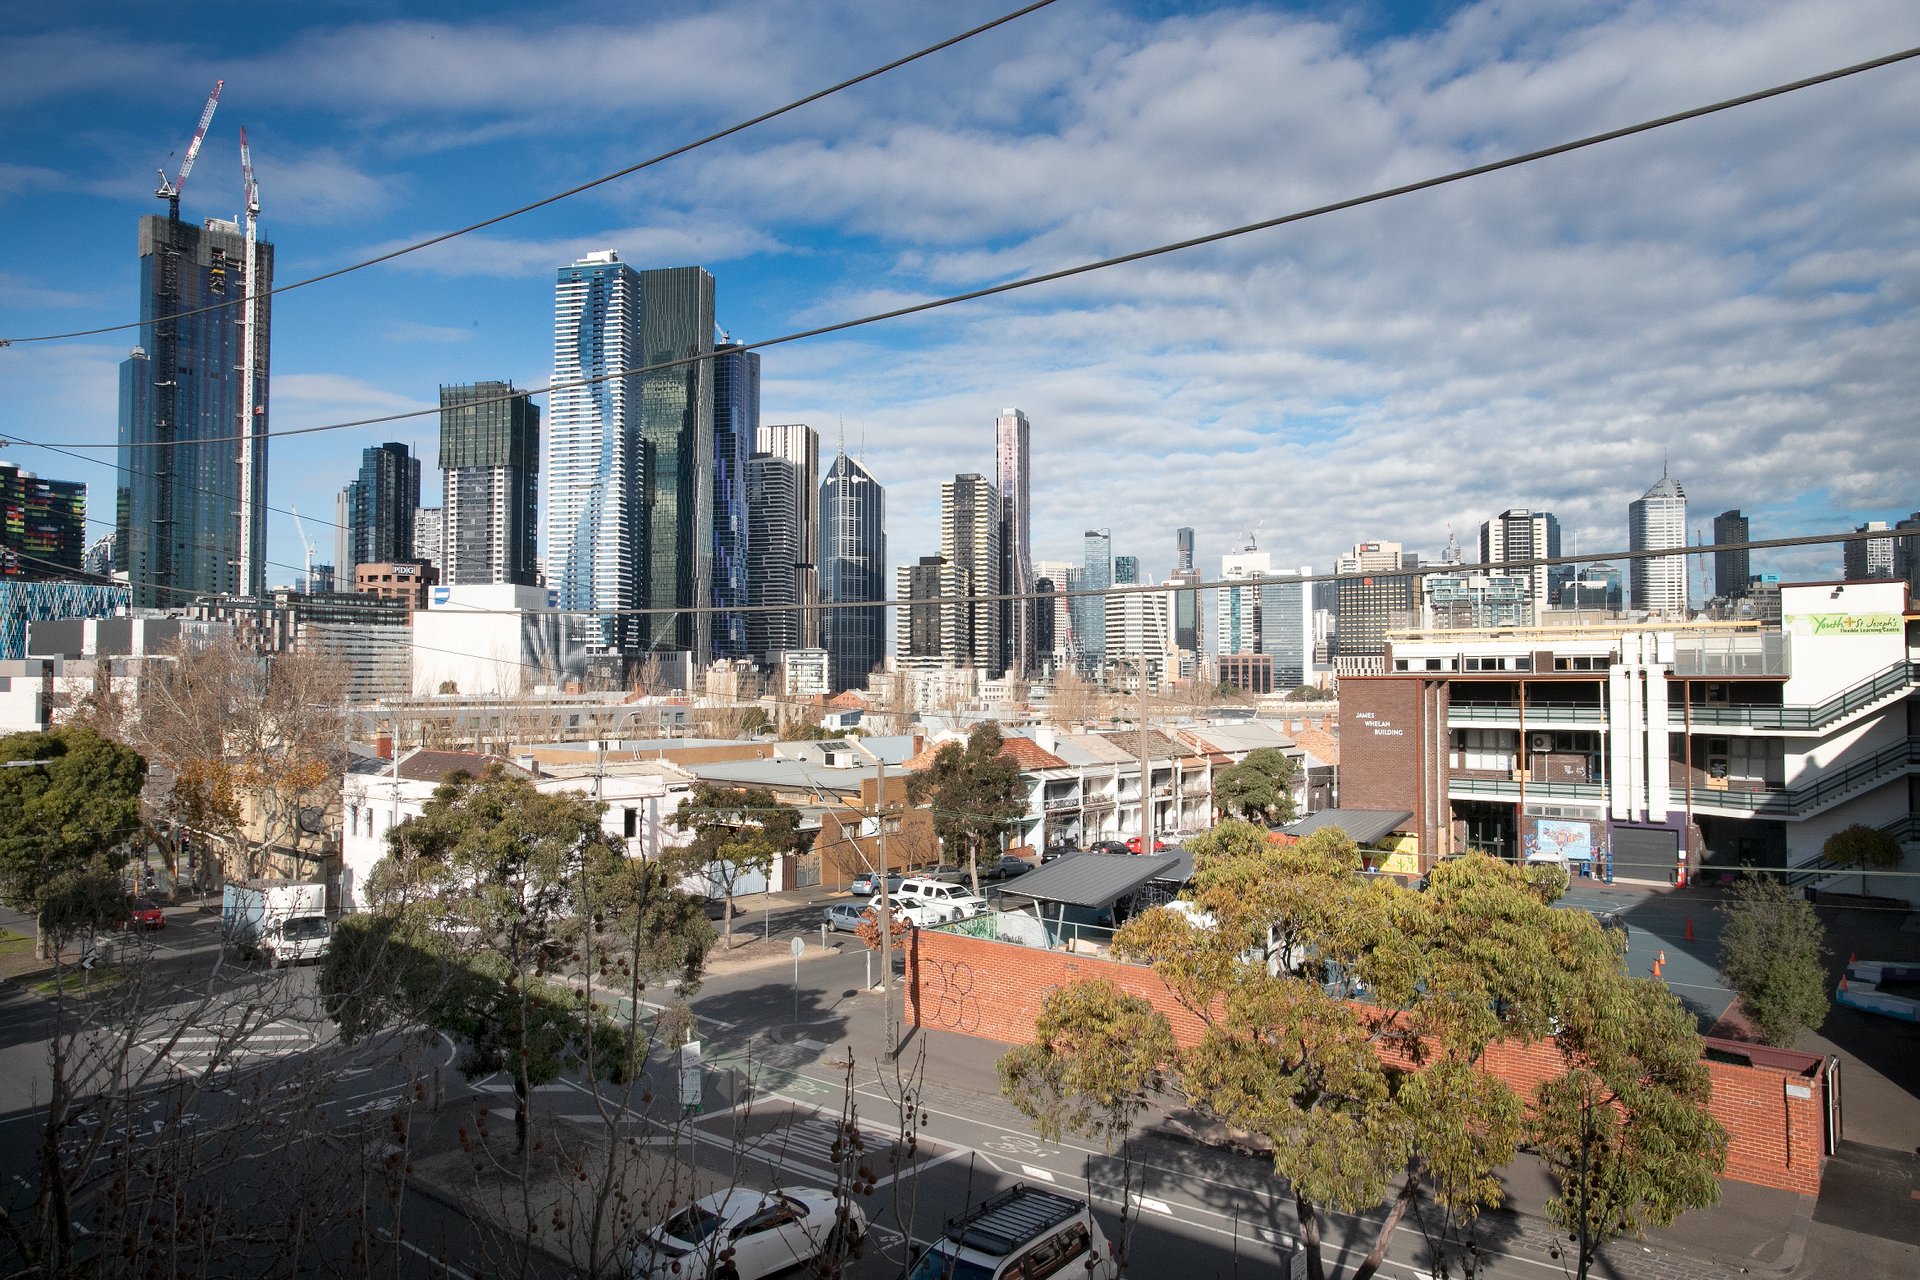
[[628, 1186, 866, 1280]]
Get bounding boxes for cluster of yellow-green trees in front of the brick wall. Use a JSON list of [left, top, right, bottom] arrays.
[[1002, 836, 1726, 1280]]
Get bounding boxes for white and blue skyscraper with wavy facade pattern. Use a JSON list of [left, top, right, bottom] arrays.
[[545, 249, 641, 647]]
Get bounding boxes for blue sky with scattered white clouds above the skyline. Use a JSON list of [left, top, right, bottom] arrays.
[[0, 0, 1920, 610]]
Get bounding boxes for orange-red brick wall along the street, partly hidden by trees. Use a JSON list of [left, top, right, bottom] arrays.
[[906, 929, 1826, 1196]]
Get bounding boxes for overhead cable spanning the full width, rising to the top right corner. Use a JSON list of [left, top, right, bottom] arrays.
[[13, 46, 1920, 449]]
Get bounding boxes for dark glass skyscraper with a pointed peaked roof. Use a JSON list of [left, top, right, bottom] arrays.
[[816, 449, 887, 693]]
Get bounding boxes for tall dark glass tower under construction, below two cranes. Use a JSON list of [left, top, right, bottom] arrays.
[[115, 217, 273, 608]]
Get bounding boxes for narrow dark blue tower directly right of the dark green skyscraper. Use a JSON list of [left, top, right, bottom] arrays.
[[708, 344, 756, 664]]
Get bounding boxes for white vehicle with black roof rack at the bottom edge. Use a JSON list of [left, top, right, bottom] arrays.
[[906, 1182, 1119, 1280]]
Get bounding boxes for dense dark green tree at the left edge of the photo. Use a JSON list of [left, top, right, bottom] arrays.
[[0, 725, 146, 954]]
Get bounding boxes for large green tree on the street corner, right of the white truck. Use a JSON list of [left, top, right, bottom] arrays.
[[321, 766, 712, 1150]]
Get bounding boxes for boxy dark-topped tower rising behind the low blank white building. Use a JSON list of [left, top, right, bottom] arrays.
[[441, 382, 540, 587]]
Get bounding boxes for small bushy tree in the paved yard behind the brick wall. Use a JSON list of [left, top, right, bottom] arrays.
[[1720, 875, 1828, 1048]]
